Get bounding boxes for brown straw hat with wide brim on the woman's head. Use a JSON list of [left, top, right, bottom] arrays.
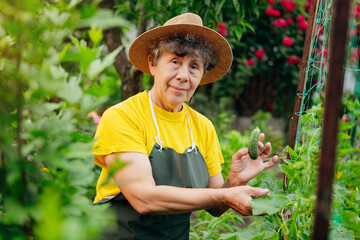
[[129, 13, 232, 84]]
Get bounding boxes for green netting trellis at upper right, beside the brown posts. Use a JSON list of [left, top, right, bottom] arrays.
[[296, 0, 360, 146]]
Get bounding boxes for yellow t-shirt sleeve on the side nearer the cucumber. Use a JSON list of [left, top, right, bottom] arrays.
[[205, 120, 224, 177]]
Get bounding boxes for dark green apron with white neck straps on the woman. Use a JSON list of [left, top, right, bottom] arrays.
[[100, 93, 210, 240]]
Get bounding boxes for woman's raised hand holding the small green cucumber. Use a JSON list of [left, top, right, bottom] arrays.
[[227, 133, 278, 187]]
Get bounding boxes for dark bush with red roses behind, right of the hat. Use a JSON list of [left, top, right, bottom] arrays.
[[224, 0, 310, 114]]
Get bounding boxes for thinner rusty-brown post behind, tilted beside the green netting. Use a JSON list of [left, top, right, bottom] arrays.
[[283, 0, 320, 191]]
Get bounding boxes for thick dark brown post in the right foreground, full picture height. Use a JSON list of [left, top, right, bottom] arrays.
[[312, 0, 351, 240]]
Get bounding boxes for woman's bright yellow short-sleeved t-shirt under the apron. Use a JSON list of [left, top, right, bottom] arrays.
[[92, 91, 224, 203]]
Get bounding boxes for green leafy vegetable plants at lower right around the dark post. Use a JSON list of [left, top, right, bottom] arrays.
[[191, 95, 360, 239]]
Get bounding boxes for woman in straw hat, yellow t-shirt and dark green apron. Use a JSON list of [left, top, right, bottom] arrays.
[[93, 13, 277, 239]]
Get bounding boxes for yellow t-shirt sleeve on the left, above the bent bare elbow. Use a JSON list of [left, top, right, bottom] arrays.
[[92, 105, 147, 167]]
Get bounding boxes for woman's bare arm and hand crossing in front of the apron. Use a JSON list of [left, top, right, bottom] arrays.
[[105, 152, 268, 215]]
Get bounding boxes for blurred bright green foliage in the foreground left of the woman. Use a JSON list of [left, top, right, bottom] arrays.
[[0, 0, 128, 240]]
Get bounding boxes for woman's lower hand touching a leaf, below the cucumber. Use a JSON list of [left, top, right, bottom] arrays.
[[224, 186, 269, 216]]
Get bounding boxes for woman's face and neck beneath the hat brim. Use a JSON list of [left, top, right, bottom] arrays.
[[149, 52, 204, 112]]
